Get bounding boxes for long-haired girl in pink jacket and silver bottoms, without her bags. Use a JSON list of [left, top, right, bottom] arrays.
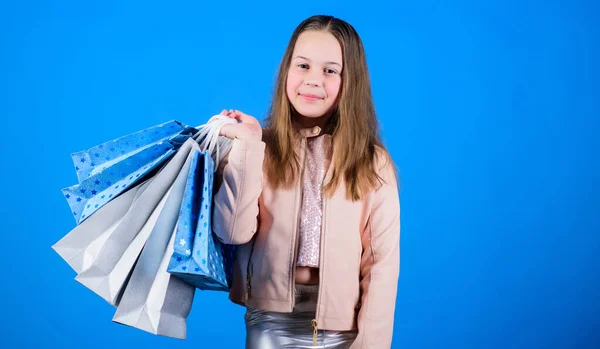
[[213, 16, 400, 349]]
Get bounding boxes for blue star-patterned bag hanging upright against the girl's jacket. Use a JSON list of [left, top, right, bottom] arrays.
[[167, 151, 235, 291]]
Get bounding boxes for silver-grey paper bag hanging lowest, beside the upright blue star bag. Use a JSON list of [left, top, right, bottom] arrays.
[[113, 146, 198, 339]]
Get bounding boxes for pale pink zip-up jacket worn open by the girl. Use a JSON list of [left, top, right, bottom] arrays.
[[213, 129, 400, 349]]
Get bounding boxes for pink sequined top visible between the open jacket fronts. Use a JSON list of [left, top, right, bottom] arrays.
[[296, 128, 331, 267]]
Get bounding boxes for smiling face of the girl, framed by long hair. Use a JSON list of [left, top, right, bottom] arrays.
[[286, 30, 343, 119]]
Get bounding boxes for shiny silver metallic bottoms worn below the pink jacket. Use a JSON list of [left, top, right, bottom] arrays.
[[244, 285, 357, 349]]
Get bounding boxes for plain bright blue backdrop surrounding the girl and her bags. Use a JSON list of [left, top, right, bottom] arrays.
[[0, 1, 600, 349]]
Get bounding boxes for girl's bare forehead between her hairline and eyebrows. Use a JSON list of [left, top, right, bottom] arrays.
[[293, 30, 342, 64]]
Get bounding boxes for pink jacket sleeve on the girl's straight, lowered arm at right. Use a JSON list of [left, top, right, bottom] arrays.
[[351, 160, 400, 349]]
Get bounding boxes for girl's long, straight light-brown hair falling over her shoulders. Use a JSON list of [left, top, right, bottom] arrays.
[[263, 16, 391, 200]]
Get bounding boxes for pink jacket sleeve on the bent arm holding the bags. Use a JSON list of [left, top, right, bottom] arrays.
[[212, 138, 265, 245]]
